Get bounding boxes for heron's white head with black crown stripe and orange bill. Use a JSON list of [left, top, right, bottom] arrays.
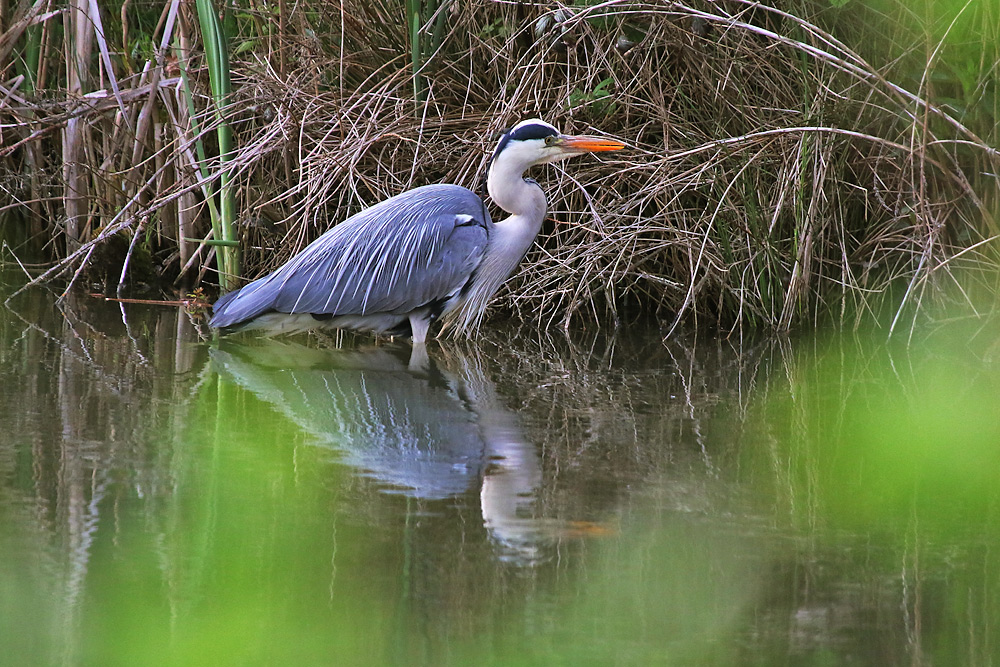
[[490, 118, 625, 173]]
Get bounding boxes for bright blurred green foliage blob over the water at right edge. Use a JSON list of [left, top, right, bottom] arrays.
[[747, 325, 1000, 533]]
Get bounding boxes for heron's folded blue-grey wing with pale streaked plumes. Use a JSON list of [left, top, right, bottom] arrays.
[[212, 185, 492, 327]]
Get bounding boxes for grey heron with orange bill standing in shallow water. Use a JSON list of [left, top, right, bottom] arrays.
[[210, 119, 625, 345]]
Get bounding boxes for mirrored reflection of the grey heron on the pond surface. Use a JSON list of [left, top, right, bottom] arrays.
[[211, 338, 558, 564]]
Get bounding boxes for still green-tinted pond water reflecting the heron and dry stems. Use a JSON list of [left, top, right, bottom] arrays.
[[0, 284, 1000, 665]]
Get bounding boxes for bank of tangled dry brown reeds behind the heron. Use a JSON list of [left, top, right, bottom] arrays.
[[0, 0, 1000, 333]]
